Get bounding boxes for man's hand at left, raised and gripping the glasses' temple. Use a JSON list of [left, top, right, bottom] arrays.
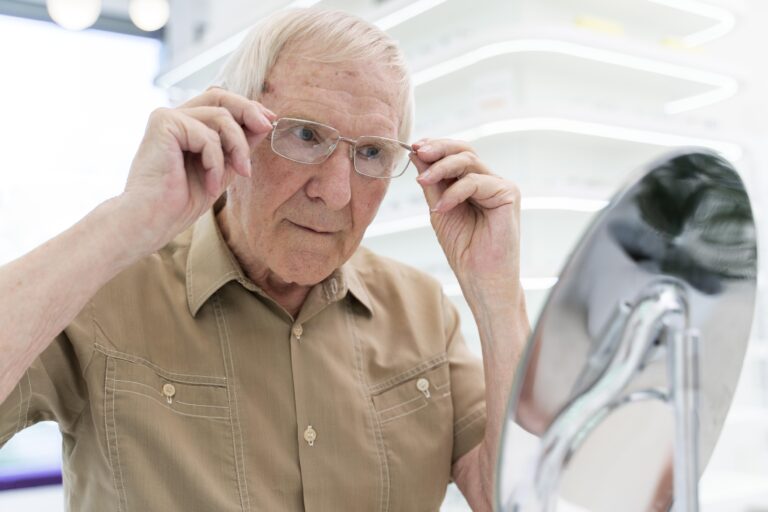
[[118, 87, 275, 254]]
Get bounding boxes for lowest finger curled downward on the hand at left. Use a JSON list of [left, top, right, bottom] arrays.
[[169, 111, 225, 196]]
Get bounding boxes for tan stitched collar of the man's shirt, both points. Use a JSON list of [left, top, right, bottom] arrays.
[[186, 201, 373, 316]]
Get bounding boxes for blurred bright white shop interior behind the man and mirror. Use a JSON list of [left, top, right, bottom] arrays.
[[0, 0, 768, 512]]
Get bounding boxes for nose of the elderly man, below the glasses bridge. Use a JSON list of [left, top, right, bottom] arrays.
[[306, 142, 355, 211]]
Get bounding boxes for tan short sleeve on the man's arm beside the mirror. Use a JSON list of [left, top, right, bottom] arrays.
[[443, 296, 485, 464]]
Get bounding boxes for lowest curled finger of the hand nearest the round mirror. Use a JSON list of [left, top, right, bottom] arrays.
[[434, 173, 520, 213]]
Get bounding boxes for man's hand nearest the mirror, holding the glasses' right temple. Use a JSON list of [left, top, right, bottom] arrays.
[[411, 139, 520, 293]]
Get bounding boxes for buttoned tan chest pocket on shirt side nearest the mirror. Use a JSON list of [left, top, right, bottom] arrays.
[[371, 355, 453, 510]]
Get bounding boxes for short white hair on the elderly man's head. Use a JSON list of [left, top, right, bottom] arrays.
[[216, 9, 414, 141]]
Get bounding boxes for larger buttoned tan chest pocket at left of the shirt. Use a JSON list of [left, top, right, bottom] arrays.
[[104, 354, 241, 511]]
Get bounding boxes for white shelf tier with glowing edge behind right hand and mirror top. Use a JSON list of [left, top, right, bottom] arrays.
[[369, 114, 741, 236]]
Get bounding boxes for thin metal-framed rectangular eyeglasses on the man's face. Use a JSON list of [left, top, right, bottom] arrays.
[[272, 117, 413, 179]]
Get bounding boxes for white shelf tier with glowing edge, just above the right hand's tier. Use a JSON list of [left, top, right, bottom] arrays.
[[413, 37, 739, 121]]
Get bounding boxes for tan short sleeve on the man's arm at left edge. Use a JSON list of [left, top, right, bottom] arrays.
[[0, 320, 94, 447]]
